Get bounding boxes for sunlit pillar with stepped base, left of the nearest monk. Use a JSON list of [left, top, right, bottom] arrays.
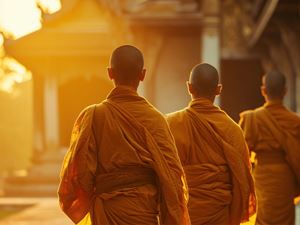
[[4, 75, 65, 196]]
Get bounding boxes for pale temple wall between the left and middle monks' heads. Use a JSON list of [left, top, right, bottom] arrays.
[[133, 25, 201, 113]]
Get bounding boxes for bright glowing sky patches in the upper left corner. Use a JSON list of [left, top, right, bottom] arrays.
[[0, 0, 61, 93]]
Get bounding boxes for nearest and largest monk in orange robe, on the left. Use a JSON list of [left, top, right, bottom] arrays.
[[58, 45, 190, 225]]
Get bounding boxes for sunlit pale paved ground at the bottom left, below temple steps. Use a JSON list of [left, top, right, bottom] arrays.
[[0, 198, 300, 225]]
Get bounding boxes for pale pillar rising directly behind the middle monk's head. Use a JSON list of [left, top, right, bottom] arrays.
[[201, 0, 221, 105]]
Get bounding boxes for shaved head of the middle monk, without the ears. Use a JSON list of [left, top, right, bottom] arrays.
[[189, 63, 219, 97]]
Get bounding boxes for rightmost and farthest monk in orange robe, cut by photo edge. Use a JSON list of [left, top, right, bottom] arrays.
[[240, 71, 300, 225]]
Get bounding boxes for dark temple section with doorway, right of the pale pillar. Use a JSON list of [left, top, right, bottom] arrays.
[[221, 0, 300, 119]]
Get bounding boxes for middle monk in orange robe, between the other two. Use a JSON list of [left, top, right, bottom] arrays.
[[167, 63, 256, 225]]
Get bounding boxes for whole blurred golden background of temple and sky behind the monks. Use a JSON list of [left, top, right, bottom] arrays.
[[0, 0, 300, 224]]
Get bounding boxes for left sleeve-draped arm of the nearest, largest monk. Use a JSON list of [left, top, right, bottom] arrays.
[[58, 109, 97, 223]]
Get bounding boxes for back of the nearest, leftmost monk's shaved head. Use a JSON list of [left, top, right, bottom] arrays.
[[110, 45, 144, 84]]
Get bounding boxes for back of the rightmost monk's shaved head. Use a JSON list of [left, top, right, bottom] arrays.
[[263, 70, 286, 99]]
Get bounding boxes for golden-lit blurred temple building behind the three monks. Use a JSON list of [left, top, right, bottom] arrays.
[[4, 0, 300, 195]]
